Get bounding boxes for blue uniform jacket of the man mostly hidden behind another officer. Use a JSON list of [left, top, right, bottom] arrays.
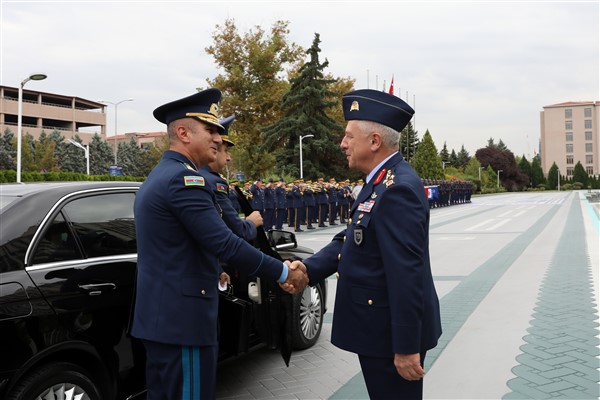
[[200, 165, 256, 241]]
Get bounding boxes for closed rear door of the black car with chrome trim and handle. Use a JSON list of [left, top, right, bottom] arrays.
[[26, 189, 144, 388]]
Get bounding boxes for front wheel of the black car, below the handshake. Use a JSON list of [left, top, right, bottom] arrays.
[[292, 285, 324, 349]]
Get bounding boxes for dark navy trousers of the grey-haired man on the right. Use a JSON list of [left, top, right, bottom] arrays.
[[358, 353, 425, 400]]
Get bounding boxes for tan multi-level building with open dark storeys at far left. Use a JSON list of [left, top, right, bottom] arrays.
[[0, 86, 106, 144]]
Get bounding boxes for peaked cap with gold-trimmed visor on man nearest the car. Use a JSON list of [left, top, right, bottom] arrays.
[[154, 88, 225, 132]]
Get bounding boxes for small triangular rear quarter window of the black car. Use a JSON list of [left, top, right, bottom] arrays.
[[31, 213, 82, 265]]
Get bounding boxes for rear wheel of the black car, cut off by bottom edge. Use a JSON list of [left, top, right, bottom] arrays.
[[8, 363, 102, 400]]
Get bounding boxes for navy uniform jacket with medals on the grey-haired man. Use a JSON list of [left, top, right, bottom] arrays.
[[304, 153, 442, 357]]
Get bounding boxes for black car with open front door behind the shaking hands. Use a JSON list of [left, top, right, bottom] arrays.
[[0, 182, 327, 400]]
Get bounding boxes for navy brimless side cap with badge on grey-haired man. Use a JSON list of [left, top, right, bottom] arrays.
[[342, 89, 415, 132]]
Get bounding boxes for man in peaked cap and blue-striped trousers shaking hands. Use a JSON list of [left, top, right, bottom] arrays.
[[132, 89, 306, 400]]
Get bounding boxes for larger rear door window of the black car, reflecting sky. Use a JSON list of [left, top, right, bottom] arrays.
[[63, 193, 137, 257]]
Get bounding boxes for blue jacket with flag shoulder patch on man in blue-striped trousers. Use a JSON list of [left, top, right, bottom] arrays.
[[132, 150, 282, 346]]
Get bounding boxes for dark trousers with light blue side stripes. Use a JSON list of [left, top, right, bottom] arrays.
[[143, 340, 219, 400]]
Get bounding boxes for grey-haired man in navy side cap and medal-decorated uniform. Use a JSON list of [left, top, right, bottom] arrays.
[[293, 89, 441, 399]]
